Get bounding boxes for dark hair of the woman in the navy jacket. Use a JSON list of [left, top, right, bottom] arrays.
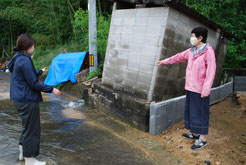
[[13, 33, 36, 52]]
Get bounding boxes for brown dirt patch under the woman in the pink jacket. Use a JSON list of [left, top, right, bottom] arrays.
[[158, 93, 246, 165]]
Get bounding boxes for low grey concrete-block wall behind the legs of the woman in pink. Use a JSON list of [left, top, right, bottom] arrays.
[[149, 82, 233, 135]]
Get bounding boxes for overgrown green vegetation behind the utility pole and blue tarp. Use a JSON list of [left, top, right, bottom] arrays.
[[0, 0, 112, 77]]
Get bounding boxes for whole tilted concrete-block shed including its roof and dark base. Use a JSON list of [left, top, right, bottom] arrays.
[[87, 0, 234, 132]]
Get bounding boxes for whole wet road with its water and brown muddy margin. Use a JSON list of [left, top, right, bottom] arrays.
[[0, 73, 183, 165]]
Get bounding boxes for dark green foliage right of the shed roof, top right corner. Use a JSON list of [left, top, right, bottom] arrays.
[[181, 0, 246, 68]]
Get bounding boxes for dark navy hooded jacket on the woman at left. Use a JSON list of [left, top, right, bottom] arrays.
[[8, 52, 53, 102]]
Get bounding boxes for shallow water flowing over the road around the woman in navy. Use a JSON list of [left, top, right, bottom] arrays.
[[0, 91, 151, 165]]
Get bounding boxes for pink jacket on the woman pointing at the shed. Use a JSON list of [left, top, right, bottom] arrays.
[[161, 44, 216, 96]]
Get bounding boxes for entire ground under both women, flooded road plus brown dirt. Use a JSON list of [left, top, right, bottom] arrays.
[[0, 73, 246, 165]]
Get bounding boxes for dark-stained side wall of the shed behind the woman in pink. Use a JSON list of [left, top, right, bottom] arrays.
[[151, 8, 227, 101]]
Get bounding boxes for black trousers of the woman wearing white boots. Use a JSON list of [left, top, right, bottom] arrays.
[[15, 102, 40, 158]]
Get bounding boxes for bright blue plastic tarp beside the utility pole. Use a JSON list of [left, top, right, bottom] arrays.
[[44, 52, 87, 85]]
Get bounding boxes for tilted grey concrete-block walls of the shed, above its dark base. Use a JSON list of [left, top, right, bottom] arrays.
[[102, 1, 228, 101]]
